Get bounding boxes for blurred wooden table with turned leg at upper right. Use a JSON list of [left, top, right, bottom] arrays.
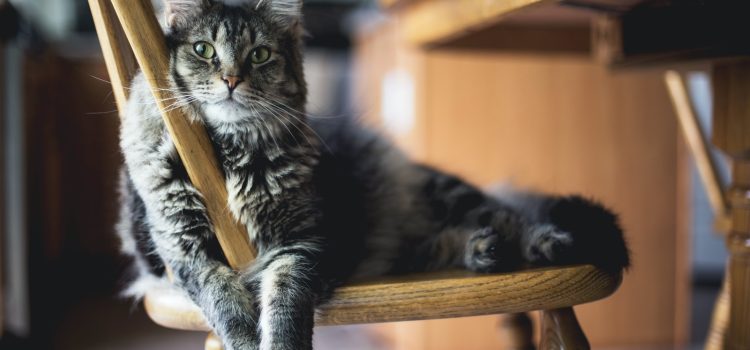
[[381, 0, 750, 349]]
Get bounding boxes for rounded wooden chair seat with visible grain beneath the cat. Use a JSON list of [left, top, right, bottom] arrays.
[[144, 265, 621, 331]]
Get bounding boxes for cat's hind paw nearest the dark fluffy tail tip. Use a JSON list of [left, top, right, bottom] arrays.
[[522, 224, 573, 264]]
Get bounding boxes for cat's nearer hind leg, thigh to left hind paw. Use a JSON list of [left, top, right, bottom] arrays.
[[409, 171, 526, 272]]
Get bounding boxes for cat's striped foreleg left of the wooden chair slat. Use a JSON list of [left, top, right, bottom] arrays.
[[145, 180, 257, 349]]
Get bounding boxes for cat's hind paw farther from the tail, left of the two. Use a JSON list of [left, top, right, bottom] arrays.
[[464, 227, 519, 272]]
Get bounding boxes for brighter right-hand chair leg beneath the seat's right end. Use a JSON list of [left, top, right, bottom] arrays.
[[539, 307, 591, 350]]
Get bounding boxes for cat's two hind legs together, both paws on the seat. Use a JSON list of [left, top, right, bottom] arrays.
[[410, 168, 573, 272]]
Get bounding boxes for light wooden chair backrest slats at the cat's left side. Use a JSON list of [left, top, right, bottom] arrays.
[[89, 0, 256, 268]]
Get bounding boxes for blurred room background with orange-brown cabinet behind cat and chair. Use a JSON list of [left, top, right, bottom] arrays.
[[0, 0, 740, 349]]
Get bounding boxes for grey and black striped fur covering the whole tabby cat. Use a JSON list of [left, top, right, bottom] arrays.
[[118, 0, 629, 349]]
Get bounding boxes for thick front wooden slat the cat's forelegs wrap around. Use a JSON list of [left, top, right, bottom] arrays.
[[107, 0, 256, 268]]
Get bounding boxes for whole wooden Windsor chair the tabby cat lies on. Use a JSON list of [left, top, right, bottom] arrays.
[[89, 0, 621, 349]]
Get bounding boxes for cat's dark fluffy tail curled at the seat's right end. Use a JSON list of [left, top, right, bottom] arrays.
[[493, 186, 630, 273]]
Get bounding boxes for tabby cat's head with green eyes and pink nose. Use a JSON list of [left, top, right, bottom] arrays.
[[164, 0, 307, 123]]
